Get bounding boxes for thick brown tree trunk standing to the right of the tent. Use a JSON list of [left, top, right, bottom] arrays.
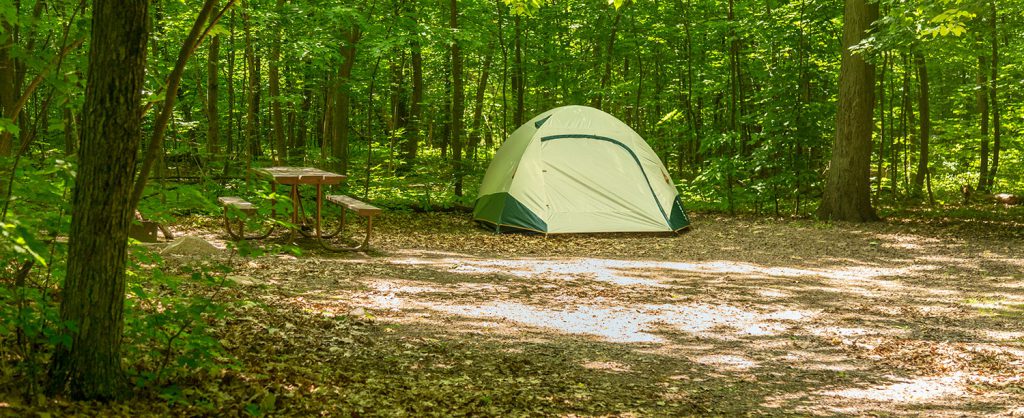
[[817, 0, 879, 222]]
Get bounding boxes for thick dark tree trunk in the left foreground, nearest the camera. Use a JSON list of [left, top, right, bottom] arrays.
[[49, 0, 150, 400]]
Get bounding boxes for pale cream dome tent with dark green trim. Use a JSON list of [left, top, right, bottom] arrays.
[[473, 106, 690, 234]]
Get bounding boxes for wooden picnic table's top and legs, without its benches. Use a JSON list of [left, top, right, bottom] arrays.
[[254, 166, 347, 244]]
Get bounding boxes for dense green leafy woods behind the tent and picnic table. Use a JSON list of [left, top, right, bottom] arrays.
[[0, 0, 1024, 214]]
